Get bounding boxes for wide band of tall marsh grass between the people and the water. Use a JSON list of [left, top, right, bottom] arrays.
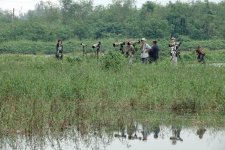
[[0, 55, 225, 135]]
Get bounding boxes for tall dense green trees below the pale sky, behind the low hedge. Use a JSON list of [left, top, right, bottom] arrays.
[[0, 0, 225, 42]]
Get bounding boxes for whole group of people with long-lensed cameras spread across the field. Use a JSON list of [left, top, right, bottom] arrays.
[[56, 37, 205, 64]]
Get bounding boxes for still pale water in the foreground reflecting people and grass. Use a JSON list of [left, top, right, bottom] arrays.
[[0, 123, 225, 150]]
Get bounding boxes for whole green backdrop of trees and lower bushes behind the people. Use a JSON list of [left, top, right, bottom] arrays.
[[0, 0, 225, 55]]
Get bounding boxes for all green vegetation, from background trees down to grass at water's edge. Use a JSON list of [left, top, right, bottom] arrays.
[[0, 0, 225, 136]]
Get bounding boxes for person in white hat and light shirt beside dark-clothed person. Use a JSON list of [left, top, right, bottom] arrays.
[[141, 38, 151, 63]]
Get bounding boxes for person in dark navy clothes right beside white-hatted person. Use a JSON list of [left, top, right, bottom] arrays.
[[149, 40, 159, 63]]
